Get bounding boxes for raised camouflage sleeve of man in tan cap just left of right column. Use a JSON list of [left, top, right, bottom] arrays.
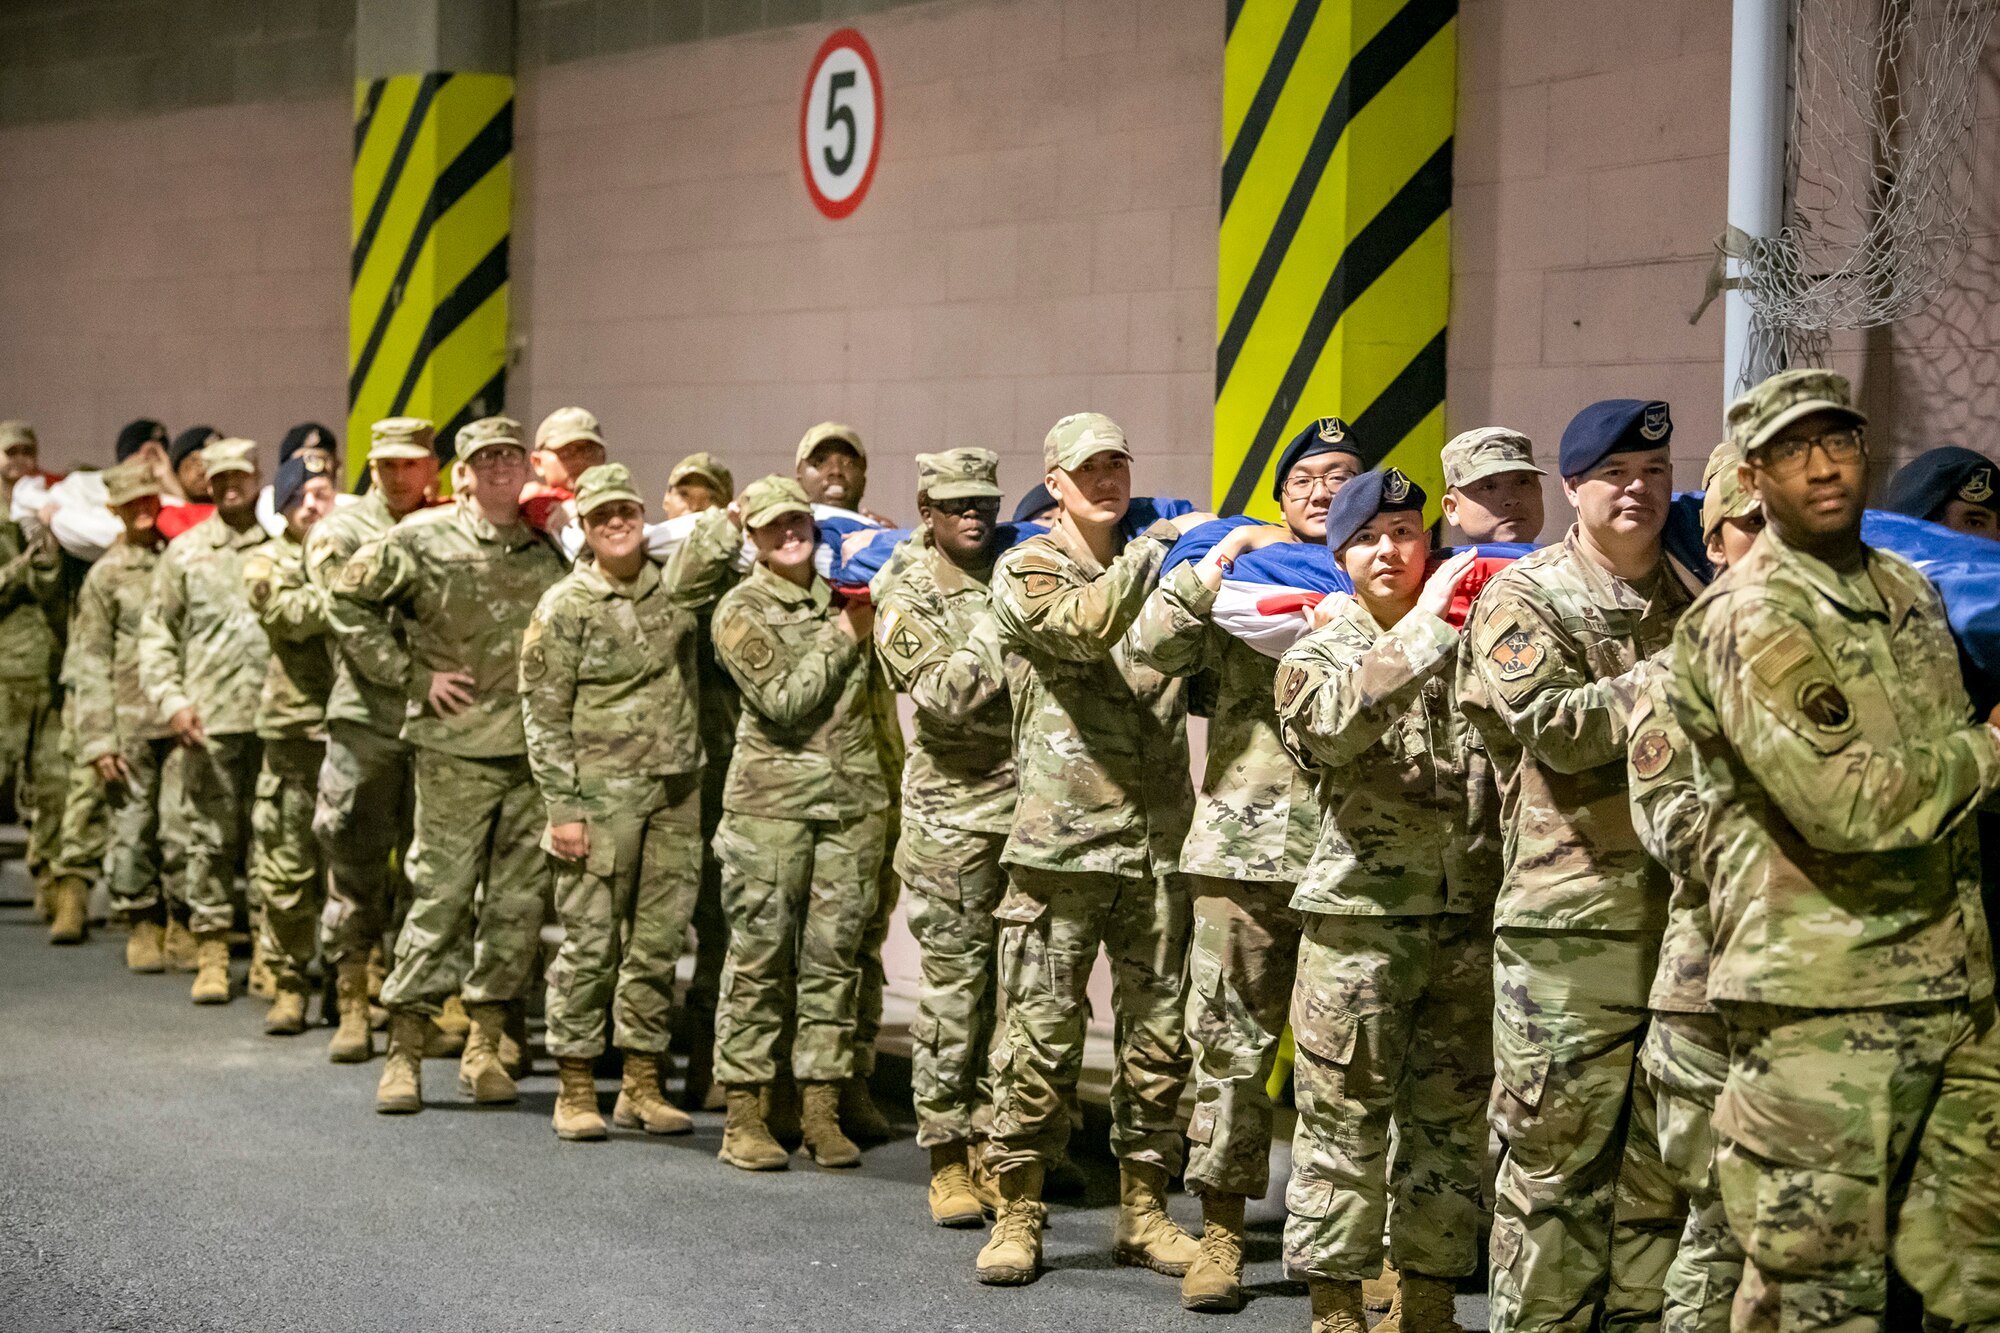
[[994, 524, 1166, 662]]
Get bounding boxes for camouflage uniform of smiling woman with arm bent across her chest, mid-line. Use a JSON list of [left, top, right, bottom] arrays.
[[714, 548, 888, 1085]]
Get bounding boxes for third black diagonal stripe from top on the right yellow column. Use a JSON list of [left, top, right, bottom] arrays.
[[1222, 140, 1452, 514]]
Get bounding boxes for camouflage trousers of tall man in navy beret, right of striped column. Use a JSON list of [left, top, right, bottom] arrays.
[[1488, 927, 1684, 1333]]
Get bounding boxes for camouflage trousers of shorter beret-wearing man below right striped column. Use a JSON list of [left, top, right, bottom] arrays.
[[1284, 913, 1492, 1281]]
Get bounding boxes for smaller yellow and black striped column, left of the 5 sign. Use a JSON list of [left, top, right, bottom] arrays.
[[348, 70, 514, 482]]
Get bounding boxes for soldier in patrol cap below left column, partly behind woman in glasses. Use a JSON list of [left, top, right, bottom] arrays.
[[304, 416, 440, 1065]]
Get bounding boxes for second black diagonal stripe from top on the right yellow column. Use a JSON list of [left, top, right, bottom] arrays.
[[1216, 0, 1458, 396]]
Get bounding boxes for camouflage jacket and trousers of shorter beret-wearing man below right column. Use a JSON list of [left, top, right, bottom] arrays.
[[1276, 598, 1500, 1281]]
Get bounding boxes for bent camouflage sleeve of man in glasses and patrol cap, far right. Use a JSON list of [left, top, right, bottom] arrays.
[[1702, 604, 2000, 853]]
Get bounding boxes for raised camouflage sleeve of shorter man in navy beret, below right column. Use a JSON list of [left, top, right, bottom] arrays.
[[1272, 610, 1458, 767]]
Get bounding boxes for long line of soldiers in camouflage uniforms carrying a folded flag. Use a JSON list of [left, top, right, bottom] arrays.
[[0, 370, 2000, 1333]]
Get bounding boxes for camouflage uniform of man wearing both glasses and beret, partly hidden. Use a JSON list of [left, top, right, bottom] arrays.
[[1130, 560, 1320, 1199]]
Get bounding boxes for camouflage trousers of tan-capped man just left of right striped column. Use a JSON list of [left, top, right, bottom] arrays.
[[986, 865, 1190, 1175]]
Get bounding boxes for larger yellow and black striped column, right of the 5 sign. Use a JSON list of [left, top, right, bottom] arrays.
[[1214, 0, 1458, 518]]
